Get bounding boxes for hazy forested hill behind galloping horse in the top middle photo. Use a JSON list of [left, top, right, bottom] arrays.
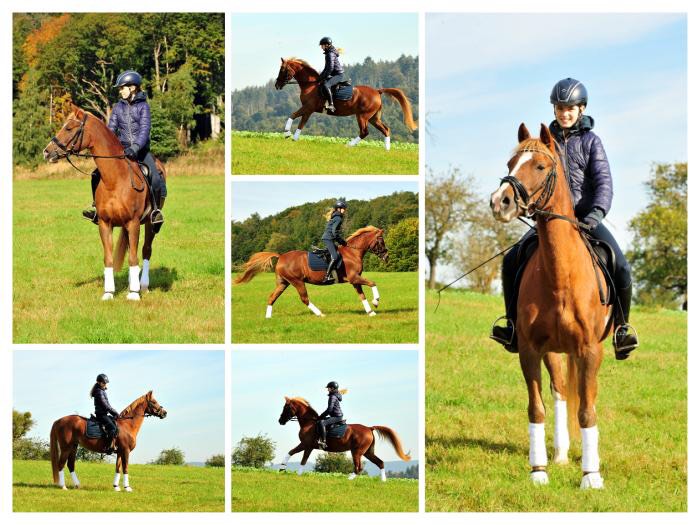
[[231, 55, 419, 142]]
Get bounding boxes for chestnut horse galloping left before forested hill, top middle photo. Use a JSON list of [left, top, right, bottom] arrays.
[[275, 58, 418, 151]]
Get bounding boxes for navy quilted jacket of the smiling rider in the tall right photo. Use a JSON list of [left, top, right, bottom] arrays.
[[549, 115, 613, 219]]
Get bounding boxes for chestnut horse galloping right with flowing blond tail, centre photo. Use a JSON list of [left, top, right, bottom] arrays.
[[233, 226, 389, 319]]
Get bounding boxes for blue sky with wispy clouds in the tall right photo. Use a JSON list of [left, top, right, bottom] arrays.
[[426, 13, 687, 280]]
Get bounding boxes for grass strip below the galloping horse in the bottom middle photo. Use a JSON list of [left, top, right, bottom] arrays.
[[231, 468, 418, 512]]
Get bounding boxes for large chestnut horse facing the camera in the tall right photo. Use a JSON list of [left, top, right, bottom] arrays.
[[491, 124, 612, 489]]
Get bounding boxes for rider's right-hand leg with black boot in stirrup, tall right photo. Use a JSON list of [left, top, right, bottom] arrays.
[[591, 223, 639, 360]]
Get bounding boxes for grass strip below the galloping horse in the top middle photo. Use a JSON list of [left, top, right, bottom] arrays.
[[231, 131, 418, 175]]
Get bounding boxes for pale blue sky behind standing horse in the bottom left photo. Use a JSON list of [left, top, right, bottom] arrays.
[[12, 349, 224, 463]]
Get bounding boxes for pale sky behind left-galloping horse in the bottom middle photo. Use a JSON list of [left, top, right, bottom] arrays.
[[231, 348, 418, 463]]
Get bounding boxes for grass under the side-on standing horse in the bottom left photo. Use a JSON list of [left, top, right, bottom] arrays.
[[12, 460, 224, 512]]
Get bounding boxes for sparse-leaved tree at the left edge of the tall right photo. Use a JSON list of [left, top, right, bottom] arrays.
[[425, 168, 478, 289]]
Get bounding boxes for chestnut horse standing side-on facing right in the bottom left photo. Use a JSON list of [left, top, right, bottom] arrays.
[[50, 391, 168, 492]]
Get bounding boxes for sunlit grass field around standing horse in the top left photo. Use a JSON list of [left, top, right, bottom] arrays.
[[13, 146, 225, 343]]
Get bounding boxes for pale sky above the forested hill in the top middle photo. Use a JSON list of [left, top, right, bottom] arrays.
[[231, 12, 418, 89]]
